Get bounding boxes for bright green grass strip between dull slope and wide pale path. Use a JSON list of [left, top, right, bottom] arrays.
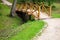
[[9, 21, 44, 40]]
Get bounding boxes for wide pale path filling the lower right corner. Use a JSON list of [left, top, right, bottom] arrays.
[[34, 18, 60, 40]]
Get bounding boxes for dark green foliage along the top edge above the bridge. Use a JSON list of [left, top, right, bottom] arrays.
[[17, 0, 55, 6]]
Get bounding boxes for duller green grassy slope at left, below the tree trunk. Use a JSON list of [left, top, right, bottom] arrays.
[[0, 4, 21, 40]]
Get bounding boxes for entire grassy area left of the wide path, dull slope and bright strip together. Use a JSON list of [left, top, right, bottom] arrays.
[[0, 4, 44, 40]]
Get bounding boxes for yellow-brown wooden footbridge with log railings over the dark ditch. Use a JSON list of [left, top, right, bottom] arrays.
[[16, 3, 51, 19]]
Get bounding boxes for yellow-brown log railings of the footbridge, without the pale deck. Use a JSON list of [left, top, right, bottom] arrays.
[[16, 3, 51, 19]]
